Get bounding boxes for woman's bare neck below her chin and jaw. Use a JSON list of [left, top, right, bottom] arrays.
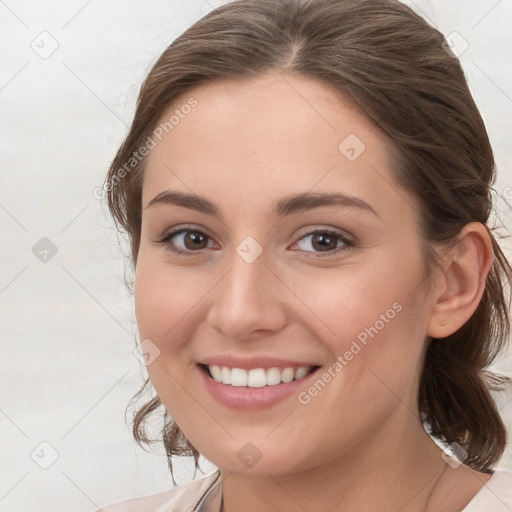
[[222, 407, 447, 512]]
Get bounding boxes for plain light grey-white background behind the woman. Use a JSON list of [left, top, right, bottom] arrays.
[[0, 0, 512, 512]]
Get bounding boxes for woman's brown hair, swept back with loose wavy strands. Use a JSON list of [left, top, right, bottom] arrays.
[[105, 0, 512, 480]]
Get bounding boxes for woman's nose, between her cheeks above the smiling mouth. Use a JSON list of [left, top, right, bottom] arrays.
[[207, 244, 293, 341]]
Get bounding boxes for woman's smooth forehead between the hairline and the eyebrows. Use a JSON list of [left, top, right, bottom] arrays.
[[143, 72, 414, 222]]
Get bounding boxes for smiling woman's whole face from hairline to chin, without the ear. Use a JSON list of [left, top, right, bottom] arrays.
[[135, 73, 431, 474]]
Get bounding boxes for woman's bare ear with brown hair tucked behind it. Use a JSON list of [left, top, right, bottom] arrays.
[[427, 222, 493, 338]]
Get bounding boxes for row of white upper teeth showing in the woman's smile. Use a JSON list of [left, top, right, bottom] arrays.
[[208, 364, 313, 388]]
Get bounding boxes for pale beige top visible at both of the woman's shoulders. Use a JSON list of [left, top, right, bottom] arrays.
[[95, 469, 512, 512]]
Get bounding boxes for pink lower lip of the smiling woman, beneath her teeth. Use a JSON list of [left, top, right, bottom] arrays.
[[197, 365, 319, 411]]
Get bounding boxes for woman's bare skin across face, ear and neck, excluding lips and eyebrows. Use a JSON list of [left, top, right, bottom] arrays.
[[135, 72, 492, 512]]
